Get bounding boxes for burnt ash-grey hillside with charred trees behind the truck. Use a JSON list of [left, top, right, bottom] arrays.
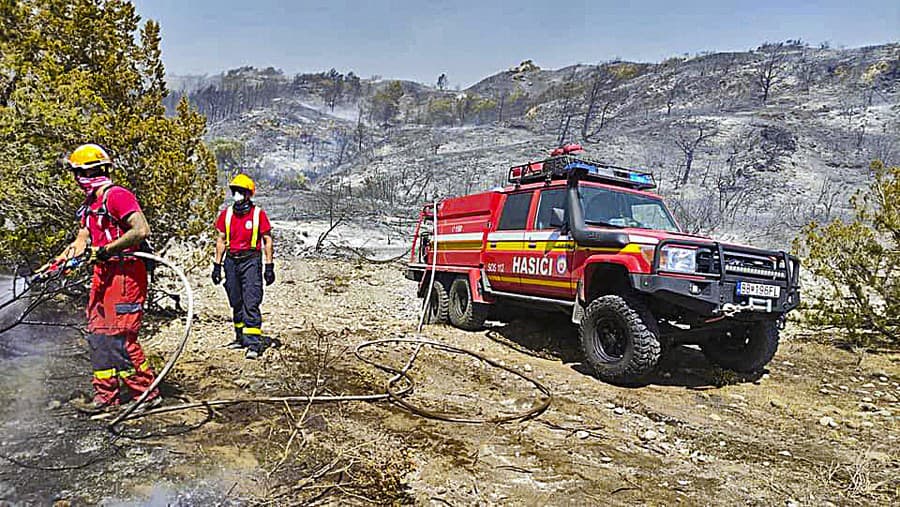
[[169, 41, 900, 245]]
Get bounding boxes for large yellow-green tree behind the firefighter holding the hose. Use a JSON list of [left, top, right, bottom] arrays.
[[0, 0, 222, 263]]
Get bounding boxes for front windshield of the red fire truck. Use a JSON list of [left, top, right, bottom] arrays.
[[579, 185, 680, 232]]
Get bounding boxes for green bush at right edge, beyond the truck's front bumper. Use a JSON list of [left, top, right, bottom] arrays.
[[795, 162, 900, 348]]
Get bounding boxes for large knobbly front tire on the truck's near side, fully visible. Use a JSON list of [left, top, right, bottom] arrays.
[[578, 296, 661, 383]]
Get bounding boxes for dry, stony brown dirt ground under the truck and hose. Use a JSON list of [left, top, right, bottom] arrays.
[[0, 259, 900, 505]]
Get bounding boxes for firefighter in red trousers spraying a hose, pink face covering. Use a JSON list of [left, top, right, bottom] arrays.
[[42, 144, 162, 412]]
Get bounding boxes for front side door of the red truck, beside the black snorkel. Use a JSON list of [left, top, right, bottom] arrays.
[[519, 187, 575, 300]]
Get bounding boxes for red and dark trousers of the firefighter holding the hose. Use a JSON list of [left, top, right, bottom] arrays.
[[87, 257, 159, 405]]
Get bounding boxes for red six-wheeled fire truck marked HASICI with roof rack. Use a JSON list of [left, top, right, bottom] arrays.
[[406, 145, 800, 382]]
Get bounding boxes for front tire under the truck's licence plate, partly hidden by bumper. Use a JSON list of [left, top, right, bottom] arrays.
[[700, 320, 779, 373]]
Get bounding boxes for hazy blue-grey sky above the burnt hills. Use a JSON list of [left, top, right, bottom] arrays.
[[135, 0, 900, 87]]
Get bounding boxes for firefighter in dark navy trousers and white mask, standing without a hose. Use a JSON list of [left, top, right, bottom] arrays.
[[212, 174, 275, 359]]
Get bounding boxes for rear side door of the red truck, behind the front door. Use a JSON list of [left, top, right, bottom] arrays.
[[484, 190, 534, 292]]
